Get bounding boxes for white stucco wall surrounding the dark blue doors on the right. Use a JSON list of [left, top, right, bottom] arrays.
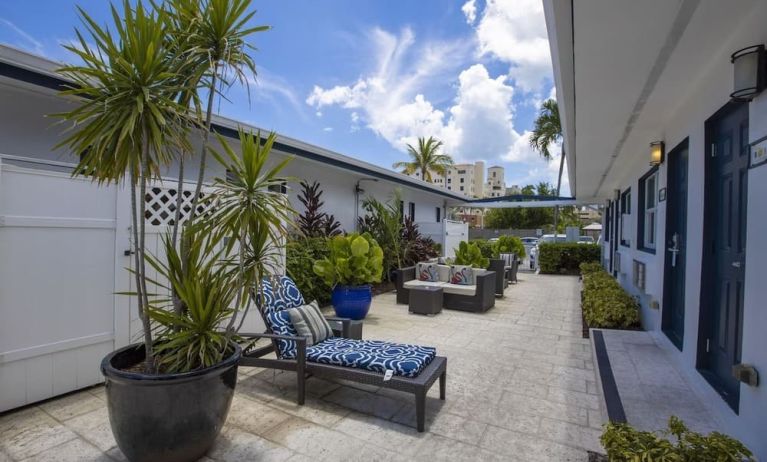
[[605, 4, 767, 458]]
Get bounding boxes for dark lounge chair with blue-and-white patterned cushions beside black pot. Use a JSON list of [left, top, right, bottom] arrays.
[[239, 276, 447, 432]]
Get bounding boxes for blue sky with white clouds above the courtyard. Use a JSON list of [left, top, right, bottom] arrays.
[[0, 0, 568, 195]]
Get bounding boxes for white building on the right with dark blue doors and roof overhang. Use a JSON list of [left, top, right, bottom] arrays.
[[544, 0, 767, 454]]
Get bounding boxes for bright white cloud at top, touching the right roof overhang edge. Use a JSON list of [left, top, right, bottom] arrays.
[[464, 0, 551, 92]]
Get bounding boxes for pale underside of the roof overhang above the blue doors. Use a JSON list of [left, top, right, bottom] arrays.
[[544, 0, 767, 199]]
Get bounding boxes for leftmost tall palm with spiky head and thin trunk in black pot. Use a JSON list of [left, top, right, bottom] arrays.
[[55, 0, 192, 371]]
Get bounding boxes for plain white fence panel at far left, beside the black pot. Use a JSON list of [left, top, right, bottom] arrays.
[[0, 162, 117, 411]]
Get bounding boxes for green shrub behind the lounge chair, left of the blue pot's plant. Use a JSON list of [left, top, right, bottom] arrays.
[[285, 237, 331, 306]]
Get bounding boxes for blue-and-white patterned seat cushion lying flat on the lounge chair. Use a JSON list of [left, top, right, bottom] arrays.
[[306, 337, 437, 377]]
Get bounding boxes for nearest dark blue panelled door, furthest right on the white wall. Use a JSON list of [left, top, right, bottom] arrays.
[[699, 103, 749, 411]]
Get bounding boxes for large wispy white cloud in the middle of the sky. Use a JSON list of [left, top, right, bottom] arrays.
[[306, 25, 531, 166]]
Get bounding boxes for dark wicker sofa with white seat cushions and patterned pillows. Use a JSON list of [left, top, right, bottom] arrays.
[[395, 265, 496, 313]]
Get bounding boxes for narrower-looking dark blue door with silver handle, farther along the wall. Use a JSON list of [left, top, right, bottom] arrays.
[[663, 140, 688, 350]]
